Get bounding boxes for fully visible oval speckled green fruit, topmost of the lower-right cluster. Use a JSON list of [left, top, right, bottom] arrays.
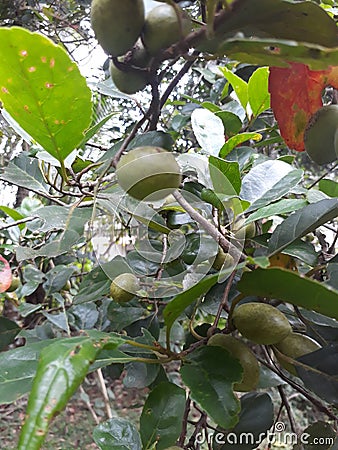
[[232, 302, 292, 345]]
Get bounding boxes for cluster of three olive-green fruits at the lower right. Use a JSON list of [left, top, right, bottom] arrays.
[[208, 302, 320, 392]]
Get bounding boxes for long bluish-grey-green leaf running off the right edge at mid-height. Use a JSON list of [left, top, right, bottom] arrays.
[[269, 198, 338, 255]]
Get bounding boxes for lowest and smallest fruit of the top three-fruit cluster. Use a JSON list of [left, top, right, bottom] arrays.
[[110, 63, 148, 95]]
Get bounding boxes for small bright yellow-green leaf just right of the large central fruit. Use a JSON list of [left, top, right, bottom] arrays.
[[209, 156, 241, 195]]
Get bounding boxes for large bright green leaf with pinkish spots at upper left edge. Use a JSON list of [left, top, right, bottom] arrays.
[[0, 27, 92, 161]]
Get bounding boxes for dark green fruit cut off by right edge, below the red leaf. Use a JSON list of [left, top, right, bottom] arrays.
[[304, 105, 338, 164]]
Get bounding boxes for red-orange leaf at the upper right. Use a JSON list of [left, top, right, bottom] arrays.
[[269, 63, 338, 152]]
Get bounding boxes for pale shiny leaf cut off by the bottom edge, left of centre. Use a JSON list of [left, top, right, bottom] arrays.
[[93, 417, 142, 450]]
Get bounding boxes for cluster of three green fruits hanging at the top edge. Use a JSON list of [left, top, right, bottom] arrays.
[[91, 0, 191, 94]]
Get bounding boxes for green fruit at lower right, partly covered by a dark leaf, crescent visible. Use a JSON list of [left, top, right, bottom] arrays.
[[208, 334, 259, 392]]
